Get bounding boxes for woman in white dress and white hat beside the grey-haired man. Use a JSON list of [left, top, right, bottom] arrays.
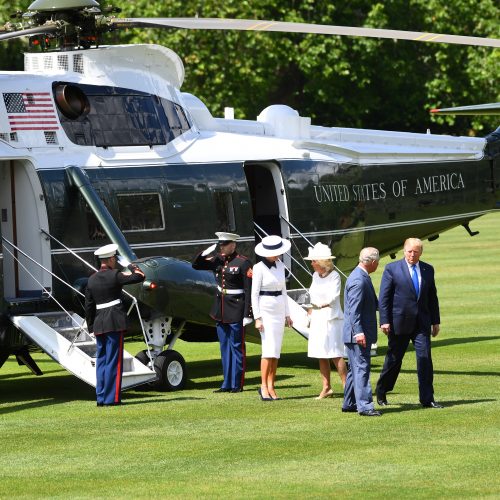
[[307, 243, 347, 399]]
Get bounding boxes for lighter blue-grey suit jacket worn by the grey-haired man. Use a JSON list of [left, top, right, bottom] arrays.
[[342, 266, 378, 346]]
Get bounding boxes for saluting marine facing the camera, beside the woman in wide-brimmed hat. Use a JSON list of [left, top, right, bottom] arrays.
[[193, 232, 252, 392]]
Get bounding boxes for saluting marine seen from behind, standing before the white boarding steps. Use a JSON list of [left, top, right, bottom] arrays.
[[85, 244, 145, 406]]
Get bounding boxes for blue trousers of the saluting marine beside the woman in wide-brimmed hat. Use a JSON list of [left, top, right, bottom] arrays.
[[217, 321, 245, 389]]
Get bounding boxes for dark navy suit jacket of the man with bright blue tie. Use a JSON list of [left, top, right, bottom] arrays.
[[379, 259, 441, 335]]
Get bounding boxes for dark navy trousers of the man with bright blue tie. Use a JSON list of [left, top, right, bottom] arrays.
[[376, 333, 434, 404]]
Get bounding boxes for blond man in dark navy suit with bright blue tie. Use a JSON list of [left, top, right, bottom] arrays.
[[376, 238, 442, 408]]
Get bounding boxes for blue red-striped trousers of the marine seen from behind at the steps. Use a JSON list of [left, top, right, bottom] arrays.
[[95, 332, 123, 405]]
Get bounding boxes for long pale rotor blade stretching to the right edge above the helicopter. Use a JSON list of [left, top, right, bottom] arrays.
[[111, 17, 500, 47]]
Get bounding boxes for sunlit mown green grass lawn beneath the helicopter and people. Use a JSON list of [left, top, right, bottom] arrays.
[[0, 214, 500, 499]]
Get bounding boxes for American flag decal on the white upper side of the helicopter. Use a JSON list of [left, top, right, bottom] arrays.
[[3, 92, 59, 132]]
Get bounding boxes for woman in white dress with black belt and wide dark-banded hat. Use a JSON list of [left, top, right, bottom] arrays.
[[252, 236, 292, 401]]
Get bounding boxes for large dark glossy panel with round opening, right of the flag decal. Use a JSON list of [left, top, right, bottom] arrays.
[[53, 82, 191, 147]]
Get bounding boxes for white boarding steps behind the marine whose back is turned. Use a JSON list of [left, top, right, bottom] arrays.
[[10, 312, 156, 389]]
